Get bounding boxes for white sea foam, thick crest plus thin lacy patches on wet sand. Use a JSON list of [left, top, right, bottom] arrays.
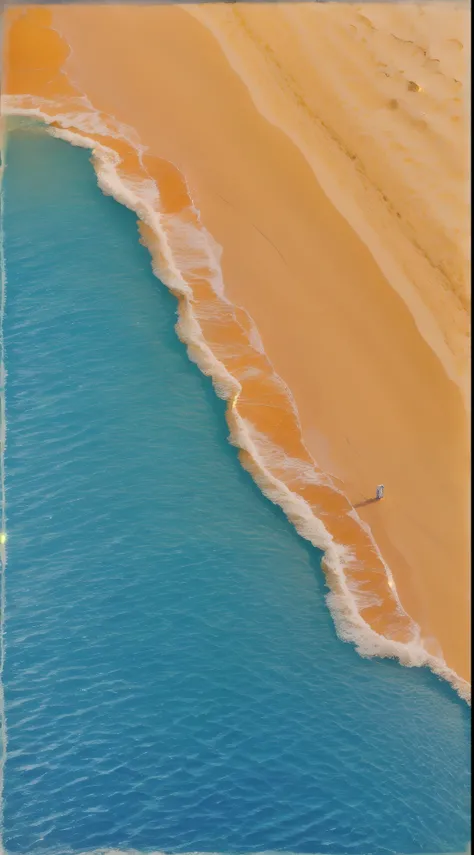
[[2, 95, 470, 703]]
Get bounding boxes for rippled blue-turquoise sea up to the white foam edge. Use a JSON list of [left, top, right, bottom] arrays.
[[3, 123, 470, 855]]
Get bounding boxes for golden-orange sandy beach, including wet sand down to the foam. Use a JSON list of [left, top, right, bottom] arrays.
[[3, 3, 470, 681]]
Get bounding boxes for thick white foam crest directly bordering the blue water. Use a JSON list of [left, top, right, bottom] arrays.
[[2, 103, 471, 704]]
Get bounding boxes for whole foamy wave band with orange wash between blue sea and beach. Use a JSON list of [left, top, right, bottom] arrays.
[[2, 90, 470, 704]]
